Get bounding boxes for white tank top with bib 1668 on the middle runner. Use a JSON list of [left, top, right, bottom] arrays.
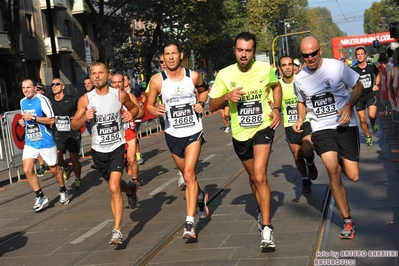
[[160, 68, 203, 138]]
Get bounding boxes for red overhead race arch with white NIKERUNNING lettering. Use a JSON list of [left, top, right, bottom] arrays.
[[331, 31, 396, 59]]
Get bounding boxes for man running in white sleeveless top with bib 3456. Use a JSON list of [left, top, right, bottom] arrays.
[[71, 62, 139, 245]]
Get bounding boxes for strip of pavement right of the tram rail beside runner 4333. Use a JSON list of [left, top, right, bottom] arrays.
[[318, 108, 399, 266]]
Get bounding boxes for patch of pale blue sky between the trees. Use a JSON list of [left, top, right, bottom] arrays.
[[308, 0, 380, 36]]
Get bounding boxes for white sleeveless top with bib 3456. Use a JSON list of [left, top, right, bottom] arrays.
[[86, 87, 125, 153]]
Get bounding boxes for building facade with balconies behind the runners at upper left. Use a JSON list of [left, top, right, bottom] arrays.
[[0, 0, 114, 113]]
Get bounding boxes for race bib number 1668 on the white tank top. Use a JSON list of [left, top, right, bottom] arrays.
[[169, 103, 196, 128]]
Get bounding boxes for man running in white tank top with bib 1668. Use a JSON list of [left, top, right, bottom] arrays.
[[147, 41, 209, 238]]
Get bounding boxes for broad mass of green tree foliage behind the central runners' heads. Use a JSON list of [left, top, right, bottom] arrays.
[[85, 0, 350, 81]]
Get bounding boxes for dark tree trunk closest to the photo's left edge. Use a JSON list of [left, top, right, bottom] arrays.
[[0, 0, 24, 106]]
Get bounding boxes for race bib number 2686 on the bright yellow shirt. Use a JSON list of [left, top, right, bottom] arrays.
[[237, 100, 263, 127]]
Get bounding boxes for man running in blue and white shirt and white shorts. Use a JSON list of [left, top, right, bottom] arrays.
[[18, 79, 69, 212]]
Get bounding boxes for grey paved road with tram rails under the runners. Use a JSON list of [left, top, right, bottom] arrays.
[[0, 106, 399, 266]]
